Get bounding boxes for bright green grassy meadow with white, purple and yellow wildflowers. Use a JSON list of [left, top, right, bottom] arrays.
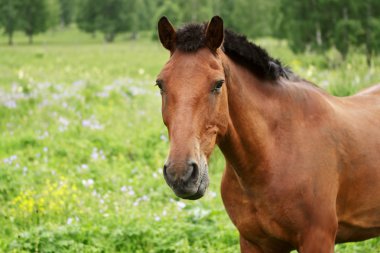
[[0, 26, 380, 253]]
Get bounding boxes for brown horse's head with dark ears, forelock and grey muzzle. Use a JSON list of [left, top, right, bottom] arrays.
[[157, 16, 228, 199]]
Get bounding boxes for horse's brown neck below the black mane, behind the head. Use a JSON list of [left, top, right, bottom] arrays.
[[218, 54, 332, 183]]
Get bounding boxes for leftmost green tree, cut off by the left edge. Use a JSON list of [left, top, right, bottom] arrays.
[[0, 0, 20, 45]]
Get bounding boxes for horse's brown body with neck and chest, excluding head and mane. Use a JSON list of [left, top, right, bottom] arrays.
[[219, 53, 380, 252]]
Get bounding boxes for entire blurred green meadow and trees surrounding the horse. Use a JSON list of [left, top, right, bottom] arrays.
[[0, 0, 380, 253]]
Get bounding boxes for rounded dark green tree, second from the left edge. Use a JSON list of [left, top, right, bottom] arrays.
[[19, 0, 49, 44]]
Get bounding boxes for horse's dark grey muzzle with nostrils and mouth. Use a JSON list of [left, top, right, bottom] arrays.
[[163, 159, 209, 200]]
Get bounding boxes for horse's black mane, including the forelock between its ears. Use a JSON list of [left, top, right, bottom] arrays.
[[176, 24, 294, 80]]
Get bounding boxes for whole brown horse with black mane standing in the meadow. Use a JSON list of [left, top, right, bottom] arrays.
[[157, 16, 380, 253]]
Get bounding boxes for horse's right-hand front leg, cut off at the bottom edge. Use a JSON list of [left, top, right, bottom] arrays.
[[298, 228, 336, 253]]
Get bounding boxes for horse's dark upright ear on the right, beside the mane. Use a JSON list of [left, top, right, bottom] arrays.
[[206, 16, 224, 51]]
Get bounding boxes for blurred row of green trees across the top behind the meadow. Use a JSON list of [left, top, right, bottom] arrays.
[[0, 0, 380, 64]]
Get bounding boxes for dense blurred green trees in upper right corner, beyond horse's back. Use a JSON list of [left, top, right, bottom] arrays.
[[277, 0, 380, 63]]
